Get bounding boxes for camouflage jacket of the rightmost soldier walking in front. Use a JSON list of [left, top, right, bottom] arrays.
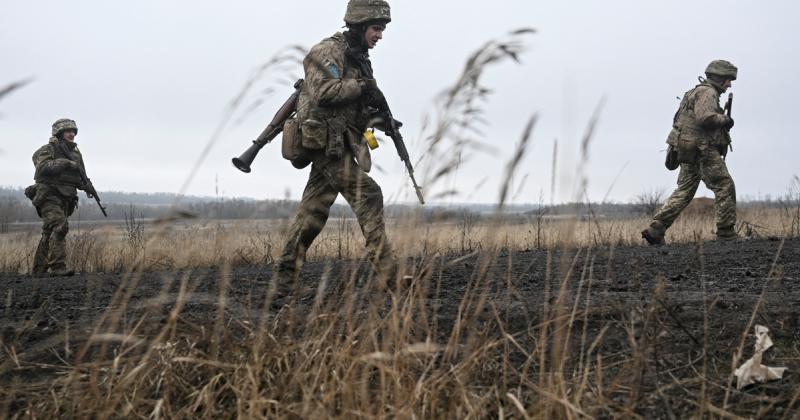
[[667, 81, 729, 149]]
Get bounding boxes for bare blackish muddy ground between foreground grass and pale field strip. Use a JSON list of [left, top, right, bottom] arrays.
[[0, 239, 800, 418]]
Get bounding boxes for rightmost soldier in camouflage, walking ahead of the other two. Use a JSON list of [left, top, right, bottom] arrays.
[[642, 60, 738, 245]]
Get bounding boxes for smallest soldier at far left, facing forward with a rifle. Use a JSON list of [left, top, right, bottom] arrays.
[[25, 119, 91, 277]]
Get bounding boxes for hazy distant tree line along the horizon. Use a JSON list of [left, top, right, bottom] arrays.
[[0, 187, 786, 232]]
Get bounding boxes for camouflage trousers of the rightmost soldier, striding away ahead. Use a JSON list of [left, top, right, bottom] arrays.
[[651, 147, 736, 235]]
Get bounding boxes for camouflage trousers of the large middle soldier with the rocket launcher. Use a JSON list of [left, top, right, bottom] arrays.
[[278, 156, 397, 279]]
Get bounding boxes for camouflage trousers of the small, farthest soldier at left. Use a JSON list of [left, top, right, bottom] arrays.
[[31, 195, 70, 274]]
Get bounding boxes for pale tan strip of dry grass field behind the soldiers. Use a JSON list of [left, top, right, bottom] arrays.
[[0, 208, 800, 273]]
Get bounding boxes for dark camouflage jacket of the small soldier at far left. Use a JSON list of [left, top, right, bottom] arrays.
[[33, 137, 83, 196]]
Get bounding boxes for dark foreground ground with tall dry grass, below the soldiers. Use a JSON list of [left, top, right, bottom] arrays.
[[0, 221, 800, 419]]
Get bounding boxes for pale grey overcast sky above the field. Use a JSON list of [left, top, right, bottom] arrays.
[[0, 0, 800, 203]]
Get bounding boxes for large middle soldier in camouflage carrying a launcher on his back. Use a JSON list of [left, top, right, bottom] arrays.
[[276, 0, 396, 287]]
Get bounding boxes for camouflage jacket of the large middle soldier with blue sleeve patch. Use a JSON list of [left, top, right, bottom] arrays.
[[297, 33, 371, 172]]
